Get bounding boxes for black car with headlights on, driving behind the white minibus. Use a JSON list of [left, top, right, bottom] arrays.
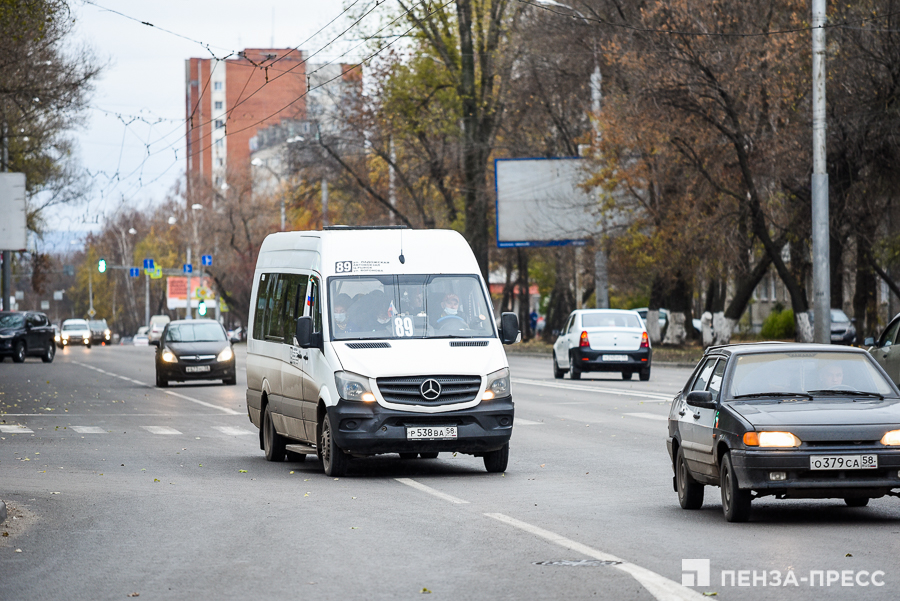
[[151, 319, 237, 387]]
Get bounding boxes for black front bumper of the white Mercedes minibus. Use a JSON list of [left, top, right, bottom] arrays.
[[327, 397, 515, 455]]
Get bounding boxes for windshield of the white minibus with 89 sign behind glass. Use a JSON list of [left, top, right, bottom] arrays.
[[328, 275, 495, 340]]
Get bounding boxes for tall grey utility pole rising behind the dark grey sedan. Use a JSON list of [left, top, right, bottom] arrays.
[[812, 0, 831, 344]]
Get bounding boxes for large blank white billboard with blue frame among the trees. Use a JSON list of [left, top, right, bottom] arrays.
[[494, 158, 601, 248]]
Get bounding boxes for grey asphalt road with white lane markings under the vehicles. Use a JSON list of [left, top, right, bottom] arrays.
[[0, 346, 900, 601]]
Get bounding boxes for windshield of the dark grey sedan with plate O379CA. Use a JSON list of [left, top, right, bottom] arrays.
[[731, 352, 895, 398]]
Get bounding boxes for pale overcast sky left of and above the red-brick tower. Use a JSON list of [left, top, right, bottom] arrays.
[[39, 0, 372, 246]]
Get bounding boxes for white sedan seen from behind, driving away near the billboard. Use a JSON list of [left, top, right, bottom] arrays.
[[553, 309, 653, 381]]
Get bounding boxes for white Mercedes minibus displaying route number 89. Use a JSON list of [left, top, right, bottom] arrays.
[[247, 226, 519, 476]]
